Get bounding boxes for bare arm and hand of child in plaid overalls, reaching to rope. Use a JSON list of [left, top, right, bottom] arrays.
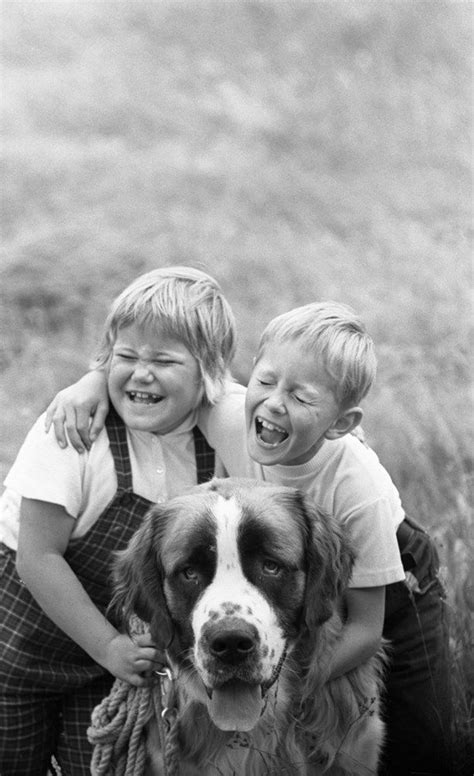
[[17, 498, 157, 687]]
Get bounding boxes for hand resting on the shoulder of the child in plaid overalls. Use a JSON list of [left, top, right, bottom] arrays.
[[45, 369, 109, 453]]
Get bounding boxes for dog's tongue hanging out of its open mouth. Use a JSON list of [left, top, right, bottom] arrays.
[[208, 679, 263, 732]]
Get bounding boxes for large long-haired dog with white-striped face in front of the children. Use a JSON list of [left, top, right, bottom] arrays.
[[114, 479, 383, 776]]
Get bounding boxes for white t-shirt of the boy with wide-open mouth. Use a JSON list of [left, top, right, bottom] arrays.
[[199, 384, 405, 587]]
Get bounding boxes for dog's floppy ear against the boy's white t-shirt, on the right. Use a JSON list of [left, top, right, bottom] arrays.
[[299, 493, 353, 632]]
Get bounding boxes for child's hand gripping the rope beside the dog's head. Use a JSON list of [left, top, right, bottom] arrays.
[[100, 633, 166, 687]]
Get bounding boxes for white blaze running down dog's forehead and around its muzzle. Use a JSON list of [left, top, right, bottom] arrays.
[[192, 496, 285, 681]]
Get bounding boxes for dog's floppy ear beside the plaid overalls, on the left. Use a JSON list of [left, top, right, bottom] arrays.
[[110, 506, 173, 649]]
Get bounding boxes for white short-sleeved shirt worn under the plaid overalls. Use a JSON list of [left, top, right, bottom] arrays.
[[0, 415, 197, 550]]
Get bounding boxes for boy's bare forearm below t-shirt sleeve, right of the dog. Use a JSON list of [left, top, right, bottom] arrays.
[[330, 587, 385, 679]]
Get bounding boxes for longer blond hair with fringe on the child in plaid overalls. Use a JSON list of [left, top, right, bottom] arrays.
[[95, 266, 235, 404]]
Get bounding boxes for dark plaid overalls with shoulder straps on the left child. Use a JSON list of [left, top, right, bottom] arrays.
[[0, 408, 214, 776]]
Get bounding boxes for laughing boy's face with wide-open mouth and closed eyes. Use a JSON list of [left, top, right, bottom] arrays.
[[245, 342, 340, 466]]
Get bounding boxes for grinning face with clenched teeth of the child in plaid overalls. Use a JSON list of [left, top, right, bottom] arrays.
[[107, 323, 203, 434]]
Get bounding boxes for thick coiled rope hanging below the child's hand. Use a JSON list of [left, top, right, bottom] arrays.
[[87, 679, 154, 776]]
